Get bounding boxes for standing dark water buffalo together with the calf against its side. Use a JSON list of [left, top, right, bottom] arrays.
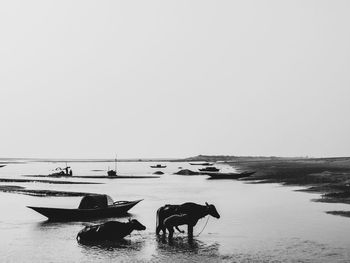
[[156, 203, 220, 240]]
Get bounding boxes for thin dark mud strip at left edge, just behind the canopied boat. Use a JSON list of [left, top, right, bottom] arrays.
[[0, 185, 94, 197]]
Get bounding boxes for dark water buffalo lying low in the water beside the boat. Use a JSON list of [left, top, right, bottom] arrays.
[[77, 219, 146, 242]]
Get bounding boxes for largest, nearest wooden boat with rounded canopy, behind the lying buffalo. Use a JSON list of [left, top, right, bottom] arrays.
[[27, 195, 142, 221]]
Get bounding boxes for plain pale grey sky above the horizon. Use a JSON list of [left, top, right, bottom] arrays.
[[0, 0, 350, 158]]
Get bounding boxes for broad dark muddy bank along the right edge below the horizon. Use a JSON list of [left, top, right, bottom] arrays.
[[227, 157, 350, 218]]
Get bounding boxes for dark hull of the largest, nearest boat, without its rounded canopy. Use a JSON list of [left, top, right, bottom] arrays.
[[27, 200, 142, 221]]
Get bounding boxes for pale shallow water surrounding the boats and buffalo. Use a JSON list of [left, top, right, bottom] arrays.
[[0, 162, 350, 262]]
